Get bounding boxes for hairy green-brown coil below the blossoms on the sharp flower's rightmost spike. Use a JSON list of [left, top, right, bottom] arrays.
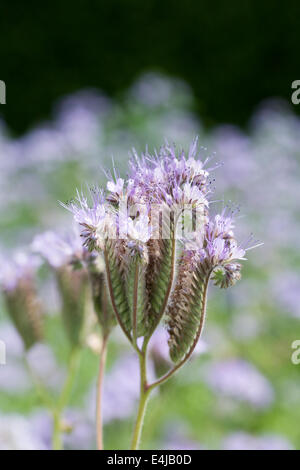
[[167, 257, 211, 363]]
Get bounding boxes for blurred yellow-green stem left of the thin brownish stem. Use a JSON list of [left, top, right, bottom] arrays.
[[52, 347, 80, 450]]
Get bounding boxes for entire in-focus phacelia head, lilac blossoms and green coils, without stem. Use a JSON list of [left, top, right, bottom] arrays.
[[63, 139, 260, 363]]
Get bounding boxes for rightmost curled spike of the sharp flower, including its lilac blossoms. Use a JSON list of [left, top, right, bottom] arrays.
[[167, 209, 262, 362]]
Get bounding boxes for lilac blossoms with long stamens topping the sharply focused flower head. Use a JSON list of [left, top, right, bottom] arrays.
[[64, 139, 258, 274]]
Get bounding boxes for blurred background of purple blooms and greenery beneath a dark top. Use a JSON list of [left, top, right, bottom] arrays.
[[0, 0, 300, 449]]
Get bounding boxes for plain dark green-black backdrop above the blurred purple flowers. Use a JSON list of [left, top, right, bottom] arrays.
[[0, 0, 300, 133]]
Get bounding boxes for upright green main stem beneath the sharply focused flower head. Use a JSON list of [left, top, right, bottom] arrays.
[[131, 354, 151, 450]]
